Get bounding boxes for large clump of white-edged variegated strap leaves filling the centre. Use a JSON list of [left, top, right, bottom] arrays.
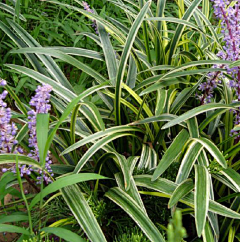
[[0, 0, 240, 242]]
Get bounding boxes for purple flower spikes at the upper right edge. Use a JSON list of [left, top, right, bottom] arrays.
[[199, 0, 240, 103]]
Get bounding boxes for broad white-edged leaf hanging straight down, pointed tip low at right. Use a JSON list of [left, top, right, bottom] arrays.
[[194, 165, 210, 237]]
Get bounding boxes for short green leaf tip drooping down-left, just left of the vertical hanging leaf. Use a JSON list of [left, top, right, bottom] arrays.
[[168, 179, 194, 208]]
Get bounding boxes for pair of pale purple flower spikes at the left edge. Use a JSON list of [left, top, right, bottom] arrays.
[[0, 79, 53, 184]]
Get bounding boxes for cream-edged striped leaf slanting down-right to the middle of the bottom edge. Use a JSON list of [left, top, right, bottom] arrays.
[[105, 187, 165, 242]]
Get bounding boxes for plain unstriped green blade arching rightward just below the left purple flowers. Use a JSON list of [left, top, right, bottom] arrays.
[[29, 173, 107, 209]]
